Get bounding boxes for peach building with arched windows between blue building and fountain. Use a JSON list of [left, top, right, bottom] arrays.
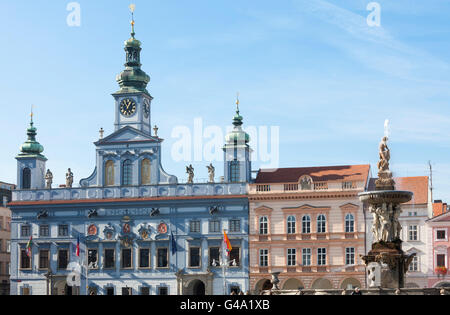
[[249, 165, 370, 292]]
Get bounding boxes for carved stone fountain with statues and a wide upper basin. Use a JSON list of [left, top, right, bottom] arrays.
[[359, 136, 415, 289]]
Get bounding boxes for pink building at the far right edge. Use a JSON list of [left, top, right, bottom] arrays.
[[427, 211, 450, 287]]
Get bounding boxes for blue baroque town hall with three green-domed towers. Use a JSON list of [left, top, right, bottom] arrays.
[[10, 21, 251, 295]]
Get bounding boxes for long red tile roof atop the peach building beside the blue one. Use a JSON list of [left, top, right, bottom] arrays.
[[255, 164, 370, 184]]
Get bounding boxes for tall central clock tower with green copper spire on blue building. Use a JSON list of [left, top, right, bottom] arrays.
[[113, 11, 153, 135]]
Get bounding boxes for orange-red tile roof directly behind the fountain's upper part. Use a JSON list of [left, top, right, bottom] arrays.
[[368, 176, 428, 204]]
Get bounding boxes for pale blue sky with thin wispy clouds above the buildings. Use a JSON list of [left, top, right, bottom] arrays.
[[0, 0, 450, 201]]
